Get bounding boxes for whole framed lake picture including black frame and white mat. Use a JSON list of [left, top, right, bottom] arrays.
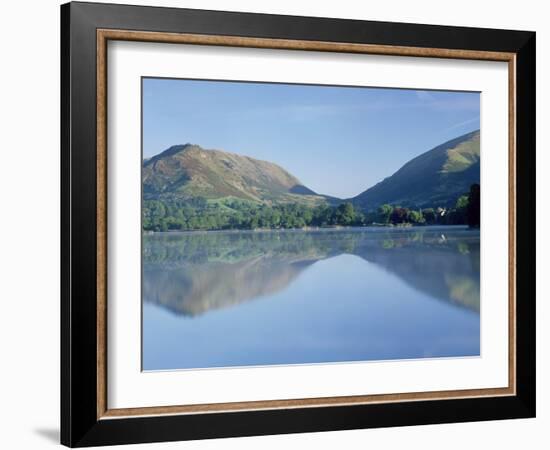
[[61, 3, 535, 447]]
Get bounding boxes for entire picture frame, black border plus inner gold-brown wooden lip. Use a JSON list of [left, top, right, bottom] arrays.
[[61, 2, 535, 447]]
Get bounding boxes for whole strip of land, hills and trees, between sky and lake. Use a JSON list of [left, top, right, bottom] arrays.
[[142, 130, 480, 231]]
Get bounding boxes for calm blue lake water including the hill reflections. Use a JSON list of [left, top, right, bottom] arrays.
[[142, 227, 480, 370]]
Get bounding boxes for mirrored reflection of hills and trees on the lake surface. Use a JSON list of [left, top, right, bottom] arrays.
[[143, 227, 479, 316]]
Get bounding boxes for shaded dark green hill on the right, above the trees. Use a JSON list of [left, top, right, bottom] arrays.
[[351, 130, 480, 210]]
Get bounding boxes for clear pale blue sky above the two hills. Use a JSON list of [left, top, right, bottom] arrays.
[[143, 78, 480, 198]]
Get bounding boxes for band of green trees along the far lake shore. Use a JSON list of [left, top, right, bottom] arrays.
[[142, 184, 479, 231]]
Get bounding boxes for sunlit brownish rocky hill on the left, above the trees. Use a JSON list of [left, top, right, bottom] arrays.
[[142, 144, 327, 204]]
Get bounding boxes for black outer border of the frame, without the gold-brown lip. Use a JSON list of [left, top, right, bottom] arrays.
[[60, 2, 536, 447]]
